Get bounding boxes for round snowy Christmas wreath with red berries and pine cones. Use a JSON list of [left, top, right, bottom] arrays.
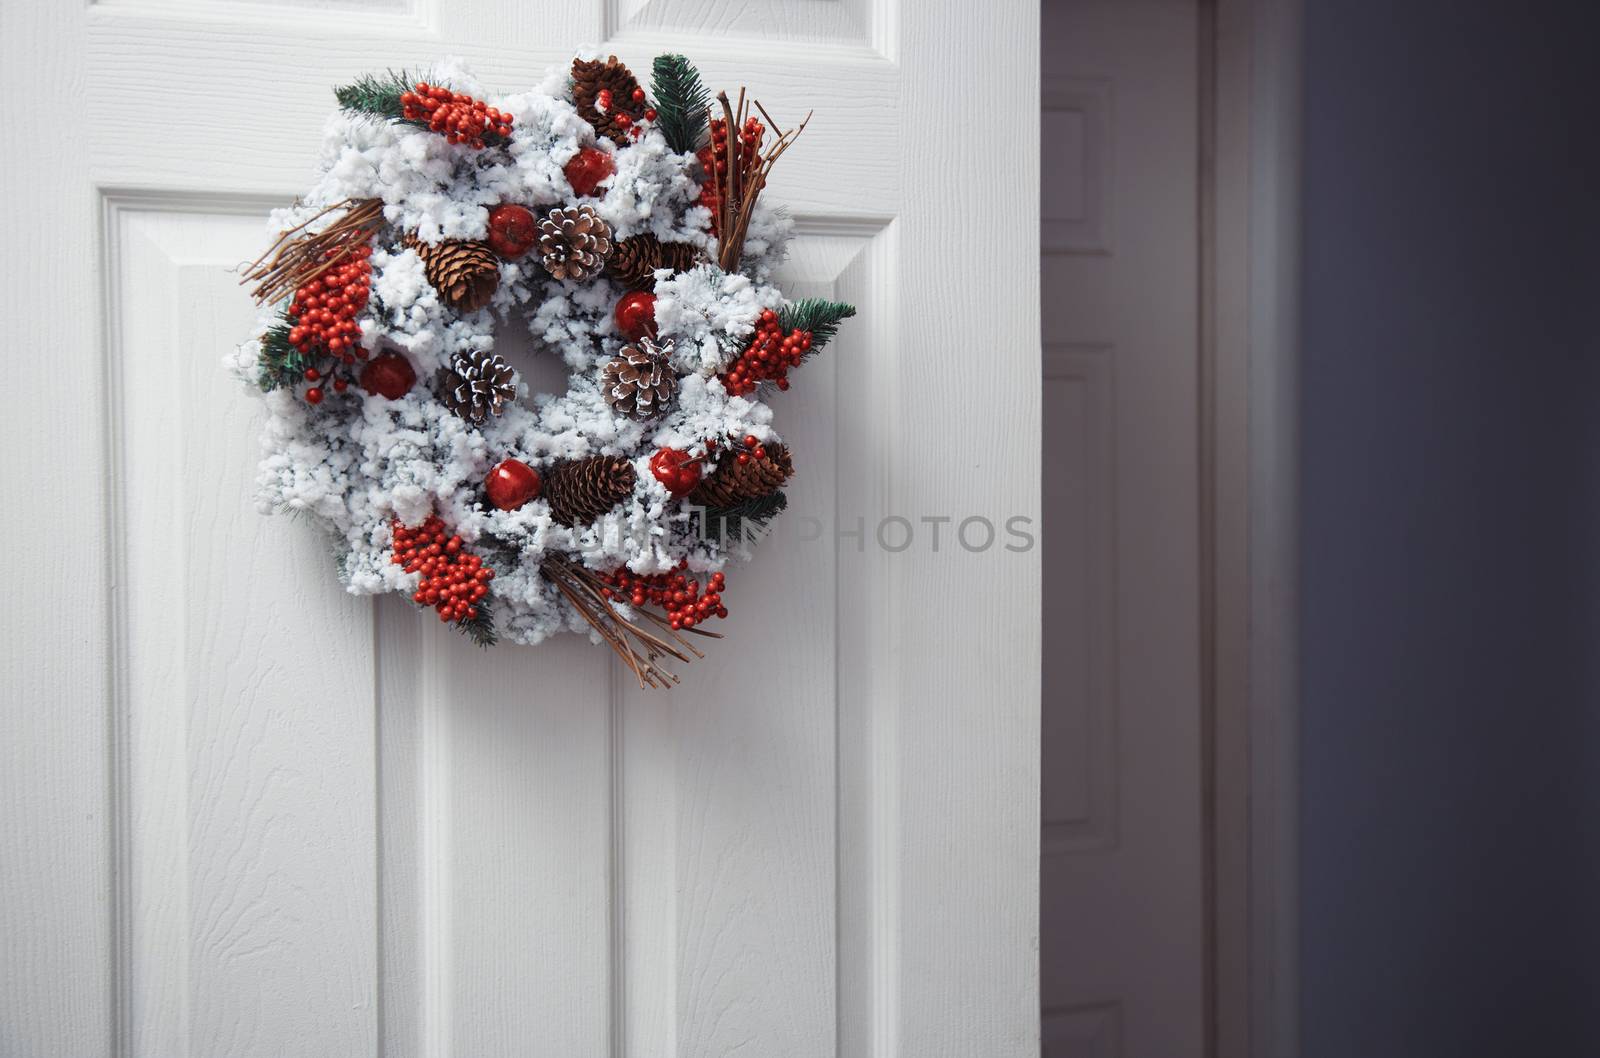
[[232, 54, 854, 687]]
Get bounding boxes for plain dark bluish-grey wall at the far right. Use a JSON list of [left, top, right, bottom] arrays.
[[1299, 0, 1600, 1058]]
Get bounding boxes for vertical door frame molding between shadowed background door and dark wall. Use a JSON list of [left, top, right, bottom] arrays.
[[1198, 0, 1302, 1058]]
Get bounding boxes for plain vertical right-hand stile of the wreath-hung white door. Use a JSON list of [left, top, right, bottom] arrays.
[[896, 3, 1040, 1058]]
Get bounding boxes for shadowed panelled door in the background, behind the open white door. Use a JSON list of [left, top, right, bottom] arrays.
[[1040, 0, 1208, 1058]]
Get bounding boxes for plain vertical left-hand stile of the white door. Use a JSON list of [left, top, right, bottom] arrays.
[[0, 3, 112, 1058]]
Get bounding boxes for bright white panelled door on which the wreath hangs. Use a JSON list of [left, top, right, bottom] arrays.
[[0, 0, 1038, 1058]]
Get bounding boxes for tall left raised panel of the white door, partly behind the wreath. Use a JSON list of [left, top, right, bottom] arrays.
[[109, 200, 376, 1058]]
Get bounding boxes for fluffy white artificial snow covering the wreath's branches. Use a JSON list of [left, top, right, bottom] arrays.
[[229, 61, 806, 643]]
